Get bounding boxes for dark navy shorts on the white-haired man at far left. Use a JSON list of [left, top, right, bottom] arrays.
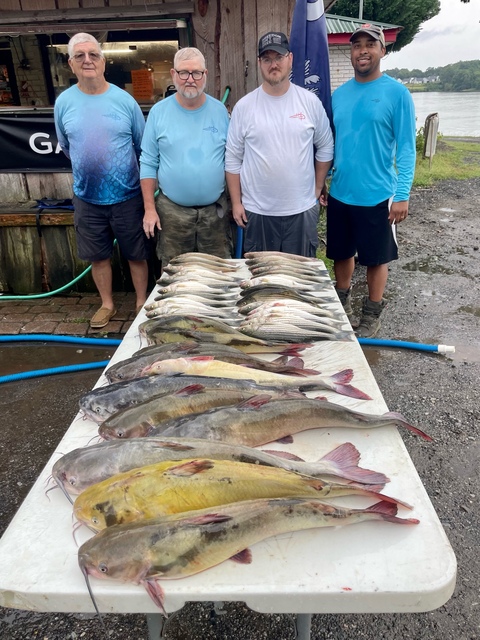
[[73, 194, 149, 262]]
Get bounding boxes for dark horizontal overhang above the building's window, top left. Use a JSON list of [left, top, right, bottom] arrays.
[[0, 0, 194, 36]]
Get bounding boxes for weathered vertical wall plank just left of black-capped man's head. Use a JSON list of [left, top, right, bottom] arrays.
[[218, 0, 245, 106]]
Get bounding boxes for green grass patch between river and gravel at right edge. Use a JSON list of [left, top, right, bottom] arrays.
[[413, 137, 480, 187]]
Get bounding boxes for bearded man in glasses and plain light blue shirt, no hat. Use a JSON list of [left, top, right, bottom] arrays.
[[140, 47, 232, 267]]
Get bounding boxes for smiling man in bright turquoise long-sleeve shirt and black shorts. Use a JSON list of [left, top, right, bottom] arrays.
[[327, 24, 415, 337]]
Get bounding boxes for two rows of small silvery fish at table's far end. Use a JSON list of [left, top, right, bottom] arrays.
[[146, 252, 352, 342]]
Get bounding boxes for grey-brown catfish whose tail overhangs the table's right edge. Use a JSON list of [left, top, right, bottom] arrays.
[[151, 397, 432, 447]]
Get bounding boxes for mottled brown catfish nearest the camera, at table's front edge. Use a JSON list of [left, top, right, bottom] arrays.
[[78, 498, 419, 615]]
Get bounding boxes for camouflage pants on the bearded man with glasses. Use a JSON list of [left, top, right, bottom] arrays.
[[155, 191, 233, 265]]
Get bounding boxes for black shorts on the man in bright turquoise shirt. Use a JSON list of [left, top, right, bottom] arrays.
[[327, 195, 398, 267]]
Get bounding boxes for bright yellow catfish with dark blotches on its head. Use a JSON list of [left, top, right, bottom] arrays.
[[73, 458, 411, 531]]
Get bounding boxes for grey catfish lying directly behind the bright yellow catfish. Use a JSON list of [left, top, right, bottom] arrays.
[[52, 438, 388, 497]]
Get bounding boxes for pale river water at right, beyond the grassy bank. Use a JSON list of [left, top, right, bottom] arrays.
[[412, 91, 480, 137]]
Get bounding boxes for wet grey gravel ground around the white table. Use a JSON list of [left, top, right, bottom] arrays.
[[0, 179, 480, 640]]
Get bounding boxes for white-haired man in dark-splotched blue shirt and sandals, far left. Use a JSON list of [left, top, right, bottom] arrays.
[[54, 33, 149, 329]]
